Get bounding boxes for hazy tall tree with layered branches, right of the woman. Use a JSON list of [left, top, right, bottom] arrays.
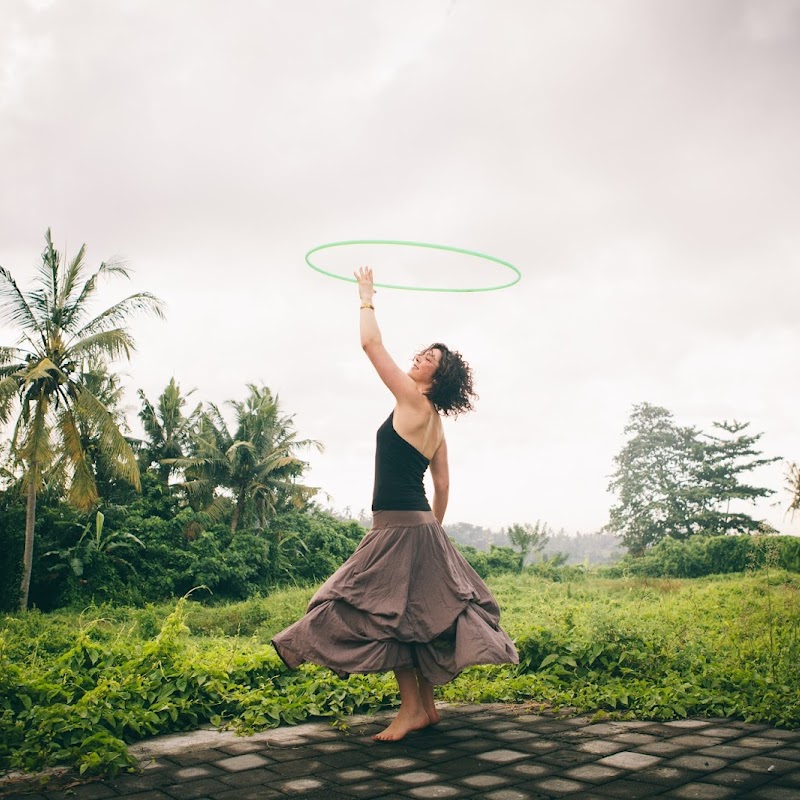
[[606, 403, 776, 554]]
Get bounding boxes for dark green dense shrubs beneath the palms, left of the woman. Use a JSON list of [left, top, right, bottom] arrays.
[[0, 484, 364, 610]]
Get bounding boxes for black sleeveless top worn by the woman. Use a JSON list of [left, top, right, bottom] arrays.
[[372, 411, 431, 511]]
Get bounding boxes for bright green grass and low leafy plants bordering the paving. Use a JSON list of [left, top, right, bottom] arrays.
[[0, 572, 800, 773]]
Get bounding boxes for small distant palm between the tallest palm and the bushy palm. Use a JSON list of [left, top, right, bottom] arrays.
[[139, 377, 201, 486]]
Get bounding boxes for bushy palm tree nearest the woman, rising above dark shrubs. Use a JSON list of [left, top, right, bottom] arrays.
[[173, 384, 322, 533]]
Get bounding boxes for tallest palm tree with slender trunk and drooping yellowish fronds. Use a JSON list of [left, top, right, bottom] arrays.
[[0, 229, 163, 610]]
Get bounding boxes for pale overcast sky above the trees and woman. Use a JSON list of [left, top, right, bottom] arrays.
[[0, 0, 800, 533]]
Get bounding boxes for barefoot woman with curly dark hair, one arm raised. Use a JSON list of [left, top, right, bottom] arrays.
[[272, 267, 518, 741]]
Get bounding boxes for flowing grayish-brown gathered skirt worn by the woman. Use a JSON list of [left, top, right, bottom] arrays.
[[272, 511, 519, 684]]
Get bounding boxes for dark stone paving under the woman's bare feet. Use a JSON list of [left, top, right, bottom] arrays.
[[0, 705, 800, 800]]
